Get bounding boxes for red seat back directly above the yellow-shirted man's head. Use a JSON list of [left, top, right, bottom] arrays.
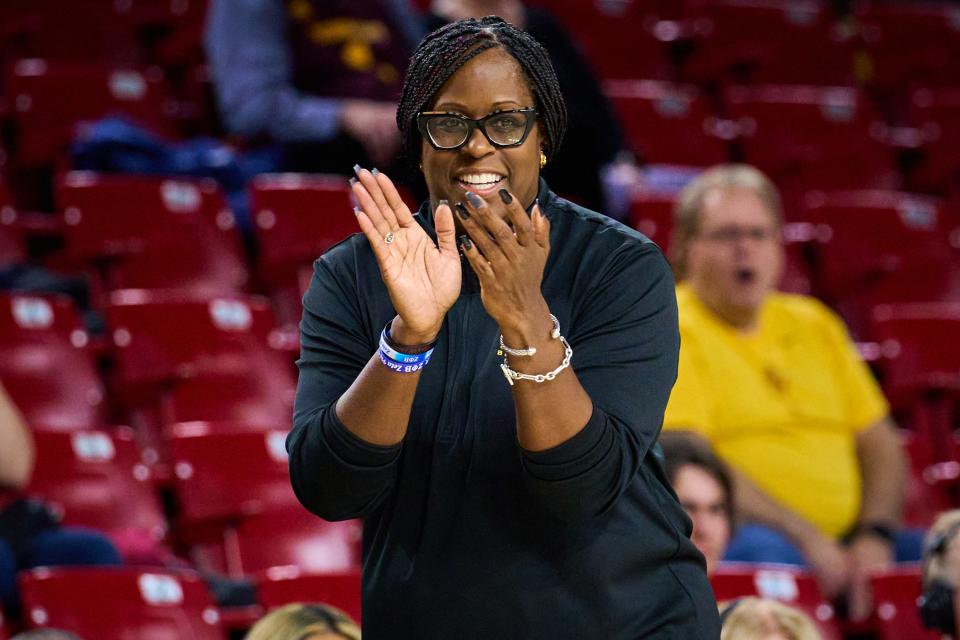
[[724, 86, 898, 198]]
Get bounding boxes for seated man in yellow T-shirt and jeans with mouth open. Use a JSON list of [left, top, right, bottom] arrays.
[[664, 165, 922, 618]]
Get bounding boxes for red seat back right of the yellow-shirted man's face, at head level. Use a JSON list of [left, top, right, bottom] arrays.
[[804, 191, 958, 333]]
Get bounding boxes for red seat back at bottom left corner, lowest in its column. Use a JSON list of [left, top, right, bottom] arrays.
[[20, 568, 226, 640]]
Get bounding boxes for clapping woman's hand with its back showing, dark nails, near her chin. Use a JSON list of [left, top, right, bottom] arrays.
[[456, 189, 550, 337]]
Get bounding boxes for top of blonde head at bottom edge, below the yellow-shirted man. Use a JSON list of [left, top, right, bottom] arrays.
[[720, 598, 822, 640]]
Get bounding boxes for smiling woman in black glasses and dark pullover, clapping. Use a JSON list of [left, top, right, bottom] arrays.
[[288, 17, 719, 639]]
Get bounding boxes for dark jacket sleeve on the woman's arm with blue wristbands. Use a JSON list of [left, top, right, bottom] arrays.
[[287, 250, 402, 520]]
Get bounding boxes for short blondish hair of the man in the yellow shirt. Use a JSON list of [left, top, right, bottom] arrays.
[[670, 164, 783, 281]]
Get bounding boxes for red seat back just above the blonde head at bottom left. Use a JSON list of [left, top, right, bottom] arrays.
[[257, 567, 361, 622]]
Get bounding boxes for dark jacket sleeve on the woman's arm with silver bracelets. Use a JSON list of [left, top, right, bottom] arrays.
[[522, 241, 680, 522]]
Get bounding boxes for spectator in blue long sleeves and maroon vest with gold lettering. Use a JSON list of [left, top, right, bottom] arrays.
[[206, 0, 421, 173]]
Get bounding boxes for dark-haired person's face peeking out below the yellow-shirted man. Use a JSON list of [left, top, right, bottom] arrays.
[[660, 433, 735, 575]]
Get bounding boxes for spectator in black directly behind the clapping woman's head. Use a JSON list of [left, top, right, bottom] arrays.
[[427, 0, 640, 215]]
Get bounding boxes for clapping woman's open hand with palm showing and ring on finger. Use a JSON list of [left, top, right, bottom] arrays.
[[352, 167, 460, 344]]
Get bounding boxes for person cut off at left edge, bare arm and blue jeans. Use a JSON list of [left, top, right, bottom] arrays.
[[0, 386, 120, 607]]
